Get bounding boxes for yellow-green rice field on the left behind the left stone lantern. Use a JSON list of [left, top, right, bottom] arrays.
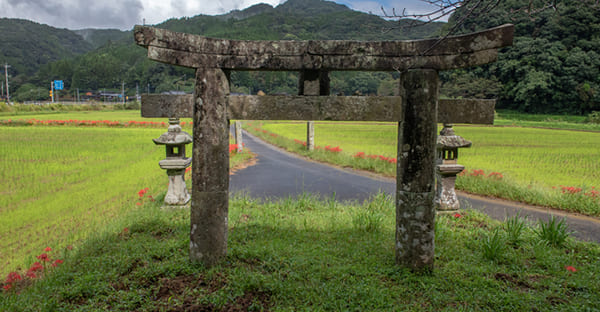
[[0, 116, 249, 274]]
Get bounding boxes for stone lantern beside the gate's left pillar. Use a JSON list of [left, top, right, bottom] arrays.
[[152, 118, 192, 206]]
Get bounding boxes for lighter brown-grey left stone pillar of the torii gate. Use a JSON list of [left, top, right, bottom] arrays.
[[190, 68, 229, 266]]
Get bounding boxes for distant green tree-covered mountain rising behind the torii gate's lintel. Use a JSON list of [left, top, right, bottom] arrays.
[[4, 0, 444, 100]]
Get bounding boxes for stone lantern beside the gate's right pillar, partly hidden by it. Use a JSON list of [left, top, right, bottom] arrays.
[[435, 124, 471, 213]]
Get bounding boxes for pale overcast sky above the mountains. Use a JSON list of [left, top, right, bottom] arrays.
[[0, 0, 440, 30]]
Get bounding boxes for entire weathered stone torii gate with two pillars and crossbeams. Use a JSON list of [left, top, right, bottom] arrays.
[[134, 24, 514, 270]]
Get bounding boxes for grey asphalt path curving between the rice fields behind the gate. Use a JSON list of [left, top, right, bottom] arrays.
[[229, 132, 600, 243]]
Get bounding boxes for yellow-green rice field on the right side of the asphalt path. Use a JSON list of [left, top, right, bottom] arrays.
[[246, 122, 600, 216]]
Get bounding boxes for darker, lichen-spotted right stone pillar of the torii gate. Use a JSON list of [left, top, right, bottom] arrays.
[[396, 69, 439, 271]]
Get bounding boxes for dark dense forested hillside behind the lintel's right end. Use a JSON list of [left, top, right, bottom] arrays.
[[443, 0, 600, 114]]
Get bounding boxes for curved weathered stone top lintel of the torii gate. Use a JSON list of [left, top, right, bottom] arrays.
[[134, 24, 514, 71]]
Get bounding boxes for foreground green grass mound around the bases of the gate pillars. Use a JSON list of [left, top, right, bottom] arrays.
[[0, 195, 600, 311]]
